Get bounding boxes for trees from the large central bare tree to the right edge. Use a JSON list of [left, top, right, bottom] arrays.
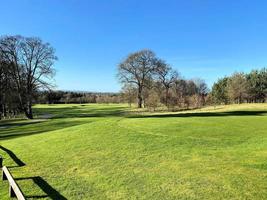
[[117, 50, 267, 110]]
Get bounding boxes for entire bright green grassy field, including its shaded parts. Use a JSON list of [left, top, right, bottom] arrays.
[[0, 104, 267, 200]]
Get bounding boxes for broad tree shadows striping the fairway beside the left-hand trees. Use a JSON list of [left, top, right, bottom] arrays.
[[0, 105, 125, 140]]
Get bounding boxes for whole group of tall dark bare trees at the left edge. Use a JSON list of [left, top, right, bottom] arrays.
[[0, 35, 57, 119]]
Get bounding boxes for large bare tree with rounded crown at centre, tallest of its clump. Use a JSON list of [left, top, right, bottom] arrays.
[[118, 50, 157, 108]]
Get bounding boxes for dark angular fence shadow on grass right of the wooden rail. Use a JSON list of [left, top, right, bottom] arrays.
[[15, 176, 67, 200]]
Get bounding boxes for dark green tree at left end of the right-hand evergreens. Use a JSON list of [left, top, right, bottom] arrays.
[[211, 77, 229, 104]]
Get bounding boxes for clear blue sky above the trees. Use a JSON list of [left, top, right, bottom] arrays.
[[0, 0, 267, 92]]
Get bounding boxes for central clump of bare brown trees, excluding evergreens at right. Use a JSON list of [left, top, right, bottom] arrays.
[[117, 49, 208, 110]]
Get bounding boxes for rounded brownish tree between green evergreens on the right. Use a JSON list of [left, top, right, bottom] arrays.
[[227, 73, 248, 104]]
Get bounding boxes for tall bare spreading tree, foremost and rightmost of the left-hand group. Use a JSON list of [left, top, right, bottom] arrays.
[[0, 36, 57, 119]]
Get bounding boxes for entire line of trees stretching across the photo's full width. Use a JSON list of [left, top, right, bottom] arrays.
[[0, 35, 267, 119]]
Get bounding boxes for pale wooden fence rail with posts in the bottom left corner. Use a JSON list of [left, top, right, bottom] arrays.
[[2, 166, 25, 200]]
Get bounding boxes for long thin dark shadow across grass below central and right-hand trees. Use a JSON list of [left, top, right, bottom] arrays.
[[128, 111, 267, 118]]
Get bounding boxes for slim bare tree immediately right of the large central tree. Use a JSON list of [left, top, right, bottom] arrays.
[[156, 60, 178, 108]]
